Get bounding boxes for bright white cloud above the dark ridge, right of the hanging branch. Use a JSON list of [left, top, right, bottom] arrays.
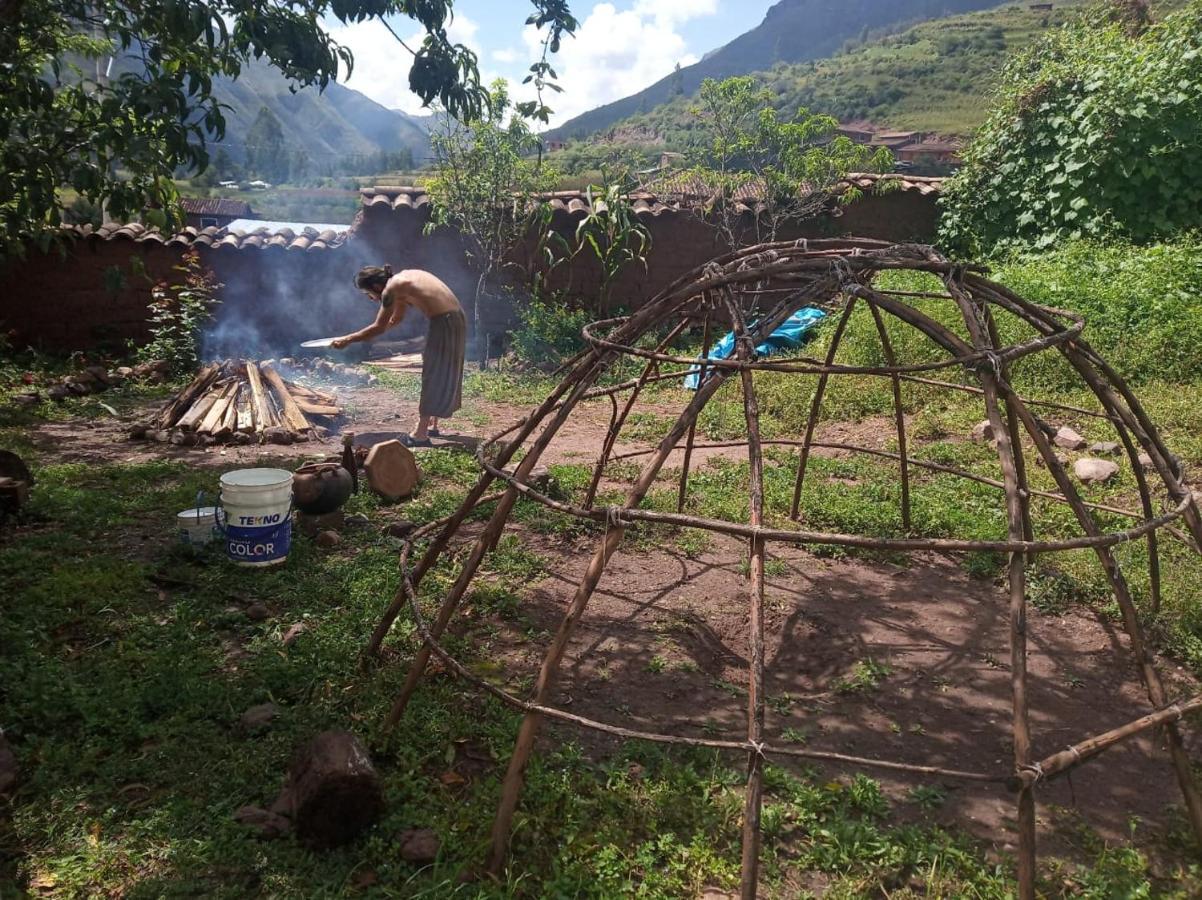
[[523, 0, 716, 125]]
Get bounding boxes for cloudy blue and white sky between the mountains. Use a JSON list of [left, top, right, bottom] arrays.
[[331, 0, 774, 125]]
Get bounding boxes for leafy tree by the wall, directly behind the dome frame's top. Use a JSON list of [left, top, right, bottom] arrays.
[[685, 76, 893, 246]]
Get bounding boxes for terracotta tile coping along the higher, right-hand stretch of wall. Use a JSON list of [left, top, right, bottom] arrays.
[[359, 172, 944, 216]]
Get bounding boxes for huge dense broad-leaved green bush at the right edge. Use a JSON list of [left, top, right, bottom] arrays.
[[942, 0, 1202, 252]]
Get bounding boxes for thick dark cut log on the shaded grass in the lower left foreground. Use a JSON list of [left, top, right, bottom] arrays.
[[272, 732, 383, 848]]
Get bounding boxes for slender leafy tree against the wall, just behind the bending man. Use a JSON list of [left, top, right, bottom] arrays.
[[427, 79, 558, 364]]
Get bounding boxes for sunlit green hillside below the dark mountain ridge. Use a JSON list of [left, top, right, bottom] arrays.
[[572, 0, 1180, 149]]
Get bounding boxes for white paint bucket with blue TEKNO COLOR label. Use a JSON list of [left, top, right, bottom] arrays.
[[221, 469, 292, 566]]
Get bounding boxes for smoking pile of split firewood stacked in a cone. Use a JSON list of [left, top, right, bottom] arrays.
[[131, 359, 343, 446]]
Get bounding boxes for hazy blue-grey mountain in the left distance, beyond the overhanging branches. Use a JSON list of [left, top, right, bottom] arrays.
[[212, 60, 430, 171]]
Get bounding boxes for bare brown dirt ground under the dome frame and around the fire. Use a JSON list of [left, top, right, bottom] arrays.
[[11, 374, 1202, 853]]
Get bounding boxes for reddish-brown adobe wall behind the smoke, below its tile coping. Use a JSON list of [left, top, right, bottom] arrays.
[[0, 191, 939, 354]]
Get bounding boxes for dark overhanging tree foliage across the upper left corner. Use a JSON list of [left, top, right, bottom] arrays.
[[0, 0, 577, 258]]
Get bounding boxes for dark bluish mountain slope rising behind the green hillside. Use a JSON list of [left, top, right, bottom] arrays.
[[547, 0, 1009, 141]]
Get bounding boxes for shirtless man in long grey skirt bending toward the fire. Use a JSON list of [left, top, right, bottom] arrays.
[[341, 266, 468, 447]]
